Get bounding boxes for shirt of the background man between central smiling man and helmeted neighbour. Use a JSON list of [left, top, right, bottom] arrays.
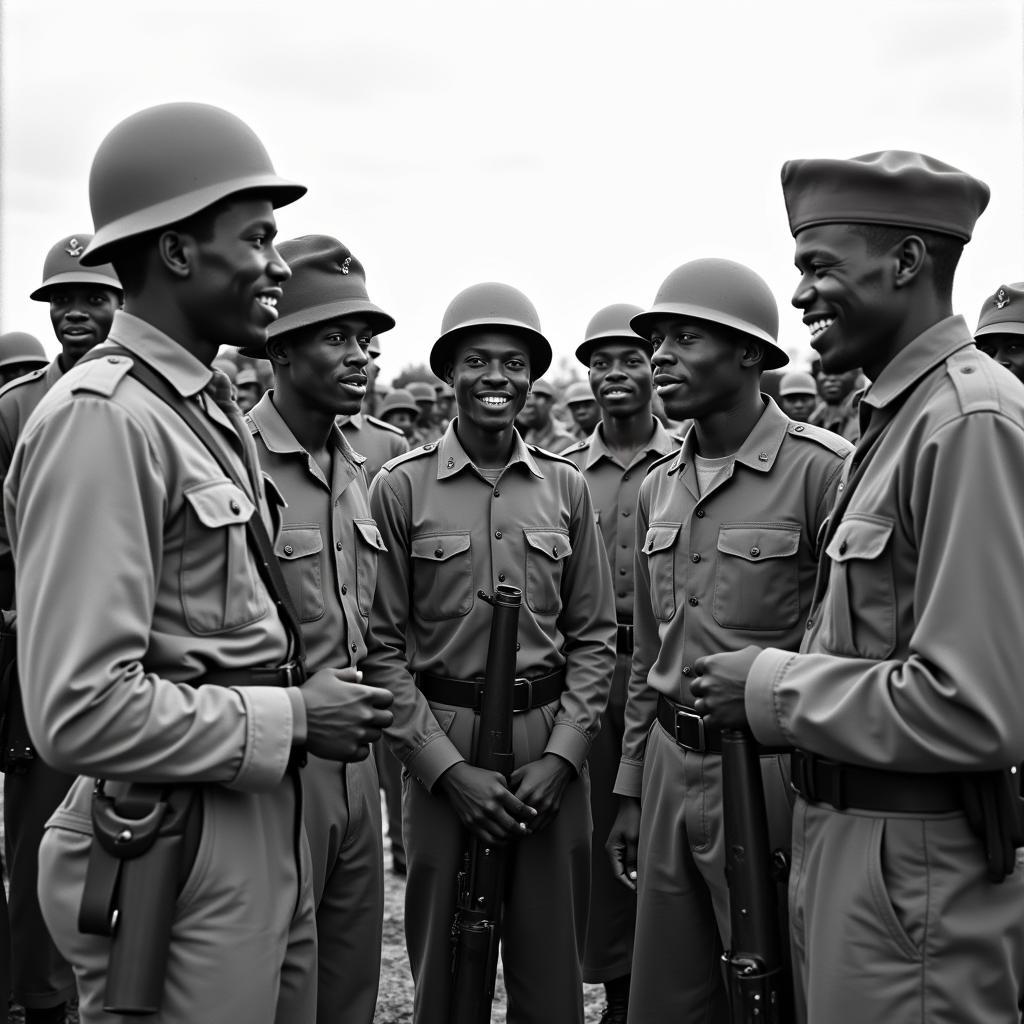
[[562, 418, 681, 623]]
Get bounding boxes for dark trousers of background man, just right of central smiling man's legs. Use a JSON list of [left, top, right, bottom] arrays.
[[583, 654, 637, 984]]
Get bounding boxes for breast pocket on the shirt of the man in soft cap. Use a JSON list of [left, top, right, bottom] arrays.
[[821, 513, 896, 660]]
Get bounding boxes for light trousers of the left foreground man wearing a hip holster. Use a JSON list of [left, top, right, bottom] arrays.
[[39, 773, 316, 1024]]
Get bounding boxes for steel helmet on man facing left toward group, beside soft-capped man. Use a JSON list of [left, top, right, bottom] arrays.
[[630, 259, 790, 370]]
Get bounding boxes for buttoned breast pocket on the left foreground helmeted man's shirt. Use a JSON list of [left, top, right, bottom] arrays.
[[178, 480, 269, 635]]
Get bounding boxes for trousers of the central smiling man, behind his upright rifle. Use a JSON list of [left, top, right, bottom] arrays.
[[402, 706, 591, 1024]]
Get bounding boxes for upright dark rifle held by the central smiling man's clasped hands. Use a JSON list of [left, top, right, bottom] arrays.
[[450, 586, 522, 1024]]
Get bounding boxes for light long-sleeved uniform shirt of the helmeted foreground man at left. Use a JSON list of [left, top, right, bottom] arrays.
[[4, 311, 305, 790]]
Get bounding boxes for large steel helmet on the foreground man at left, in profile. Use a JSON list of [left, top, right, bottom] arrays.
[[82, 103, 306, 266]]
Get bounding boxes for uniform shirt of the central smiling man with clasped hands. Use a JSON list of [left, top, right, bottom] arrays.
[[367, 419, 615, 790]]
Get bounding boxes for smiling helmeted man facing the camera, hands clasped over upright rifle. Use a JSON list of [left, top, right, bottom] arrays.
[[365, 284, 614, 1024]]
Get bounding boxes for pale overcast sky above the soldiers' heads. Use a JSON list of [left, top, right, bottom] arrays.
[[0, 0, 1024, 380]]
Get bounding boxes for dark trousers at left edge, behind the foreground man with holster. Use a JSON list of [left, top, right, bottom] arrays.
[[3, 757, 75, 1009]]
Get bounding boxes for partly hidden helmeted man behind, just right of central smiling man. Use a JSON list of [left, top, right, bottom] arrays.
[[563, 302, 681, 1024]]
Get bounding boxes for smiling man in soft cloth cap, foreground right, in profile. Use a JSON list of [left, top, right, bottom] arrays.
[[693, 151, 1024, 1024]]
